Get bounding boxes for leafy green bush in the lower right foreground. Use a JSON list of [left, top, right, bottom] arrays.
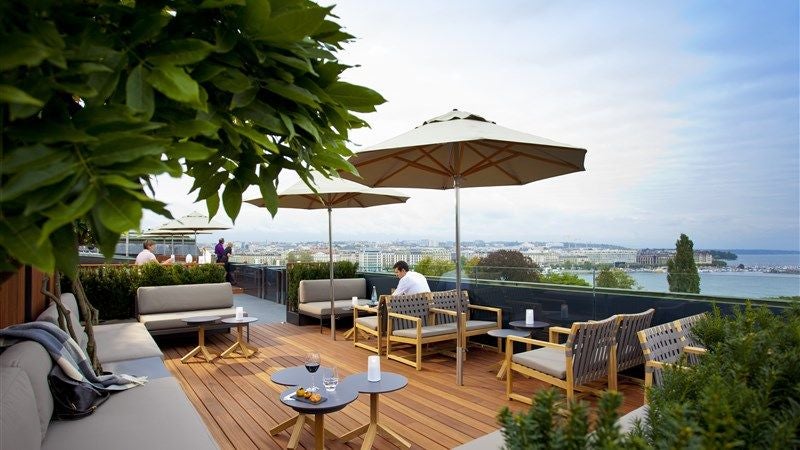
[[499, 304, 800, 449]]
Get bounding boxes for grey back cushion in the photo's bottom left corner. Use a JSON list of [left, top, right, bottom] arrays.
[[0, 367, 42, 450]]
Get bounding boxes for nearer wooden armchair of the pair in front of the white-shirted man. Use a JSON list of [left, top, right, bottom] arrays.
[[386, 292, 458, 370]]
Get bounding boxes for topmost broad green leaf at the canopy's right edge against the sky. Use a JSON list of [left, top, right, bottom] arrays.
[[256, 6, 331, 43]]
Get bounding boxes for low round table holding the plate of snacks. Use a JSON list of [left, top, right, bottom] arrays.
[[281, 384, 358, 450]]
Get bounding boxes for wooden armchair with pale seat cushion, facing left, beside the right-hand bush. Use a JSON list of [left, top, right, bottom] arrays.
[[506, 317, 618, 404]]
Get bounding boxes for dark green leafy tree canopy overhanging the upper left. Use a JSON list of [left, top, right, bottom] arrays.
[[0, 0, 385, 276]]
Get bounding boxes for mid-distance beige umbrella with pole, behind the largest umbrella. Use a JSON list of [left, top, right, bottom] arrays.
[[246, 177, 408, 340]]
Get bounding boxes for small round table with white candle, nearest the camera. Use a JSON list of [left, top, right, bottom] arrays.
[[339, 372, 411, 450]]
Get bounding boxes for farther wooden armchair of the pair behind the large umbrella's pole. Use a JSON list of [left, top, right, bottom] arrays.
[[431, 289, 503, 349]]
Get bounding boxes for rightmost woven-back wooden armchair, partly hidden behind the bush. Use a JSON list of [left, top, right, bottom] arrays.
[[637, 321, 705, 402]]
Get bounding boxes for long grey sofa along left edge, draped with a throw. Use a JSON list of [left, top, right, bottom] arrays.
[[0, 293, 219, 450]]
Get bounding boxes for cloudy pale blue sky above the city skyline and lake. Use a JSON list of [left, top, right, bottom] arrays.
[[142, 0, 800, 250]]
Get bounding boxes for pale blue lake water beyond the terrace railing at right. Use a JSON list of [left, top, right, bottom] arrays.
[[578, 253, 800, 298]]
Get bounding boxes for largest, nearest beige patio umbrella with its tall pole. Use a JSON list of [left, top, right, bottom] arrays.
[[341, 110, 586, 385]]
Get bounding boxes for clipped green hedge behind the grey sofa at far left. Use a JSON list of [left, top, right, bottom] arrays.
[[61, 264, 225, 320]]
